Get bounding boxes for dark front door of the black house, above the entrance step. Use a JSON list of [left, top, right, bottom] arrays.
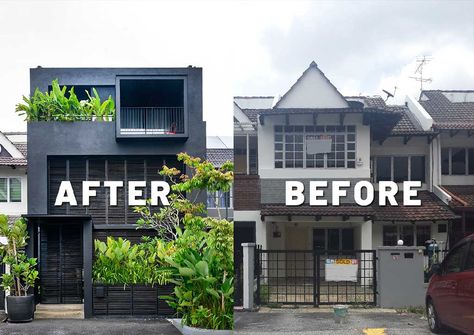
[[39, 224, 83, 304]]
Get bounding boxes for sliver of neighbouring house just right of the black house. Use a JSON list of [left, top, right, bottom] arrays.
[[206, 136, 234, 220]]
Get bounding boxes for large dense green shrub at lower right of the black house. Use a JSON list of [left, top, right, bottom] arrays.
[[165, 218, 234, 329]]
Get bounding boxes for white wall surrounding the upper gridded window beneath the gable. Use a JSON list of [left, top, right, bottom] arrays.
[[258, 113, 370, 179]]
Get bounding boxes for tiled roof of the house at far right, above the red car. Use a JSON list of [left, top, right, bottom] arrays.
[[419, 90, 474, 129]]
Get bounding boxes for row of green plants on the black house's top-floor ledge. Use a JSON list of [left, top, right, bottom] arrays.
[[16, 79, 115, 121]]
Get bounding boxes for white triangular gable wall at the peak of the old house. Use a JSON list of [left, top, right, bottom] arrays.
[[277, 66, 348, 108]]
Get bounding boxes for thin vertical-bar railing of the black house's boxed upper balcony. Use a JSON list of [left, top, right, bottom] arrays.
[[120, 107, 185, 135]]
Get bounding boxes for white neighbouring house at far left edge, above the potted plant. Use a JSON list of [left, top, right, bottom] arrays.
[[0, 132, 27, 221]]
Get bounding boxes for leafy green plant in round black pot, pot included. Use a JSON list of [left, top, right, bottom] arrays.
[[0, 215, 38, 322]]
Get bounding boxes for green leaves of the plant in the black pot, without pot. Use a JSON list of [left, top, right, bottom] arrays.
[[0, 215, 38, 296]]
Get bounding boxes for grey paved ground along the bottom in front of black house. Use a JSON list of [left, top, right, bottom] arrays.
[[0, 319, 180, 335]]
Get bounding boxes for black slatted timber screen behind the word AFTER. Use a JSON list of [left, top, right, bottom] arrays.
[[48, 156, 183, 225]]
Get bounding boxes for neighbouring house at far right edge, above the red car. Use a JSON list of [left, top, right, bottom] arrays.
[[419, 90, 474, 241]]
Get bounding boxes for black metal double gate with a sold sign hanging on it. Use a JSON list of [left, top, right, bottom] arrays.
[[255, 247, 377, 306]]
